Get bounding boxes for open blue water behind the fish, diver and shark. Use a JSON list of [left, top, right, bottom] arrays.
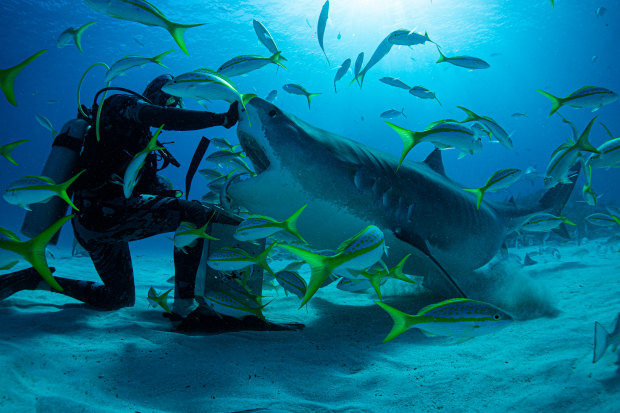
[[0, 0, 620, 246]]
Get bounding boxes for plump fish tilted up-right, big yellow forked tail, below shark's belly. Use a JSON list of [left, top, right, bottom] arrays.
[[280, 225, 385, 308]]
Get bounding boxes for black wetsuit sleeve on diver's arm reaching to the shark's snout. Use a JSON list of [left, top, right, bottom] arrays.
[[134, 101, 226, 131]]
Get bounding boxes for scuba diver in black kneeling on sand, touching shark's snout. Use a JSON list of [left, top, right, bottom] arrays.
[[0, 75, 300, 331]]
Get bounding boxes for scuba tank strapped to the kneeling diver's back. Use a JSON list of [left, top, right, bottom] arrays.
[[21, 119, 90, 245]]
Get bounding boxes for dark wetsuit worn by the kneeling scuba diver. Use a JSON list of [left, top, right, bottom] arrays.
[[46, 95, 237, 309]]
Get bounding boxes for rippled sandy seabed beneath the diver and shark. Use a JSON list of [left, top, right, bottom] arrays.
[[0, 241, 620, 412]]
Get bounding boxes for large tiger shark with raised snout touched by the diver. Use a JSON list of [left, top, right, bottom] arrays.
[[226, 98, 574, 296]]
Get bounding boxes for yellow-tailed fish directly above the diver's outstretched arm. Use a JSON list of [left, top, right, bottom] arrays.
[[162, 69, 256, 108]]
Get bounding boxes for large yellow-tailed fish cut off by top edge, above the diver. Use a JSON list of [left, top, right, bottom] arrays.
[[84, 0, 207, 54]]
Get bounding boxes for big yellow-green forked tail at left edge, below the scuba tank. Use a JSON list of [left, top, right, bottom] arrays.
[[0, 215, 73, 292]]
